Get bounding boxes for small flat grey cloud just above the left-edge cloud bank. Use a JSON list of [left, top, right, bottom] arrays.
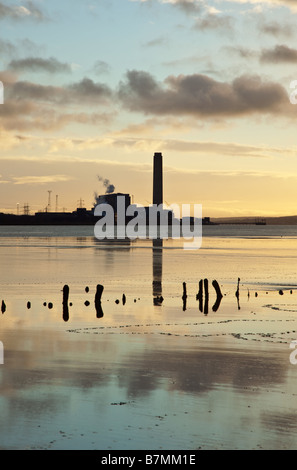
[[8, 57, 71, 73]]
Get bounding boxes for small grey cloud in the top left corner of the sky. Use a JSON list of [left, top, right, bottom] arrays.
[[0, 0, 47, 21]]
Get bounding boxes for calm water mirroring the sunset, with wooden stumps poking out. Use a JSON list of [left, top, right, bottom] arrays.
[[0, 225, 297, 450]]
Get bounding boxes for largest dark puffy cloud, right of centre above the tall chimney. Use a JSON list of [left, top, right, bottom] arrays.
[[119, 70, 289, 117]]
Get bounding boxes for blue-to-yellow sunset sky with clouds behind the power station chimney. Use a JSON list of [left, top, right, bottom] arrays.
[[0, 0, 297, 217]]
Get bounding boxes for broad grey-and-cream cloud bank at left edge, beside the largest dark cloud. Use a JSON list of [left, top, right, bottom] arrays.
[[0, 71, 115, 131]]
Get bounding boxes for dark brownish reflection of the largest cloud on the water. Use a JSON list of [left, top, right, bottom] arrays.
[[119, 349, 285, 396]]
